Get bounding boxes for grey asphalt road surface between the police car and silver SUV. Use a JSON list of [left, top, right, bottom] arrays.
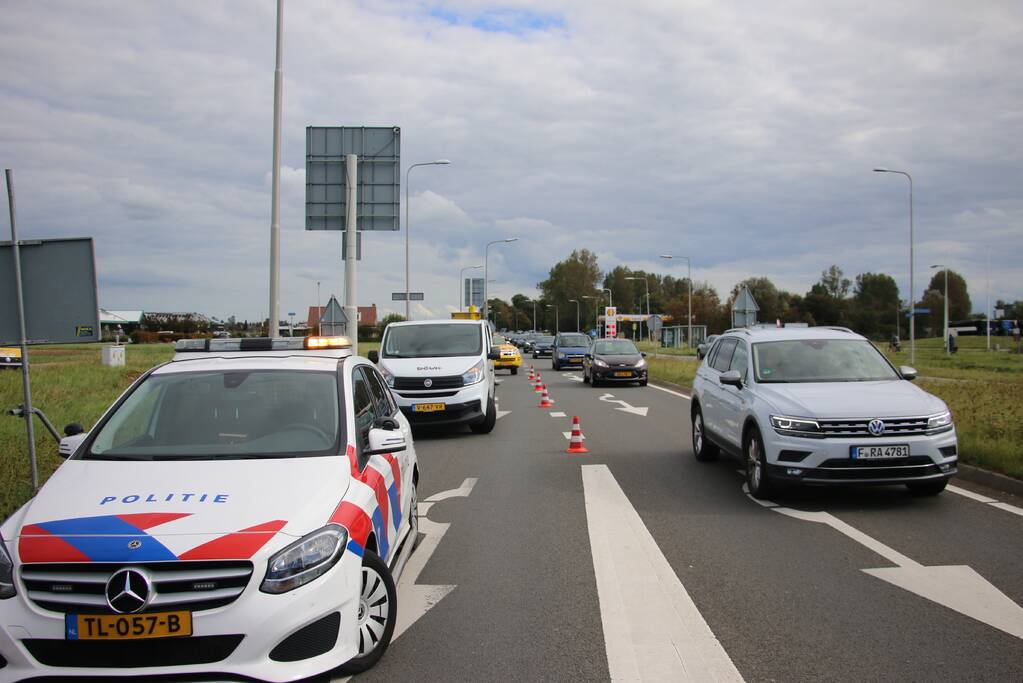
[[347, 366, 1023, 681]]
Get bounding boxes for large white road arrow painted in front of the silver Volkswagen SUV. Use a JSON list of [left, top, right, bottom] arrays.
[[743, 484, 1023, 638]]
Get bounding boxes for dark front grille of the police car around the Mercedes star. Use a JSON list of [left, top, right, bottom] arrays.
[[21, 560, 253, 614]]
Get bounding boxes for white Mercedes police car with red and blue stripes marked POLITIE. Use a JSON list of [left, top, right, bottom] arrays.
[[0, 337, 418, 681]]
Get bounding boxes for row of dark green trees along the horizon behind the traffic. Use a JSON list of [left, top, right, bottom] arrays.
[[488, 248, 1002, 339]]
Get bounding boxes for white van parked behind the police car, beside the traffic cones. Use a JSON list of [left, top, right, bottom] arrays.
[[368, 320, 500, 434]]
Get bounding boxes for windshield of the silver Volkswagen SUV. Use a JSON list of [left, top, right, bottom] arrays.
[[753, 339, 898, 383]]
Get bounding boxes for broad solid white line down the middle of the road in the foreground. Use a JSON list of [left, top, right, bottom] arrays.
[[582, 465, 743, 681]]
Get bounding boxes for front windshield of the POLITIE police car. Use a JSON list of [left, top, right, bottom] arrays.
[[83, 370, 341, 460]]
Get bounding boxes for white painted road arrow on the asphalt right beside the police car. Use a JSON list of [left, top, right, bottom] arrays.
[[331, 476, 479, 683]]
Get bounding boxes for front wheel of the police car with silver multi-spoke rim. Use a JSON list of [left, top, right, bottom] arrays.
[[339, 550, 398, 674]]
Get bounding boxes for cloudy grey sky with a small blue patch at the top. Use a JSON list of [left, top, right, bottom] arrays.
[[0, 0, 1023, 319]]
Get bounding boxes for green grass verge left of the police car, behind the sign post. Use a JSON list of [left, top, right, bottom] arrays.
[[0, 344, 174, 518]]
